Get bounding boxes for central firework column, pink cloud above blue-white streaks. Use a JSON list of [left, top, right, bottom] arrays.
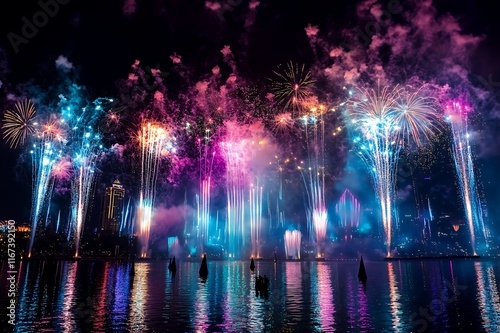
[[220, 121, 276, 258]]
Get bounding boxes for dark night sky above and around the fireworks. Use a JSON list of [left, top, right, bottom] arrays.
[[0, 0, 500, 237]]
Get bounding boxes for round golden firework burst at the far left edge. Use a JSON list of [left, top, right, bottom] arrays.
[[2, 99, 36, 148]]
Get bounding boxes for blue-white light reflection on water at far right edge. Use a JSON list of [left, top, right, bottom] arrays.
[[474, 262, 500, 332]]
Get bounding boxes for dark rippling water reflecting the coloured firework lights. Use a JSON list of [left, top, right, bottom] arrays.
[[0, 260, 500, 333]]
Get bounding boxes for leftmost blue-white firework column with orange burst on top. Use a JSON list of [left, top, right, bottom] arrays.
[[28, 115, 65, 257]]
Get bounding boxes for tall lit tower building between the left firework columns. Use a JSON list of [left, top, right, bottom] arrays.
[[101, 180, 125, 234]]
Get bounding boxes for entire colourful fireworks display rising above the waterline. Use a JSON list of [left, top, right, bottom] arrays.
[[2, 53, 487, 259]]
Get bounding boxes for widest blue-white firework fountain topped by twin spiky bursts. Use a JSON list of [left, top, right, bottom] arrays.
[[346, 86, 438, 257]]
